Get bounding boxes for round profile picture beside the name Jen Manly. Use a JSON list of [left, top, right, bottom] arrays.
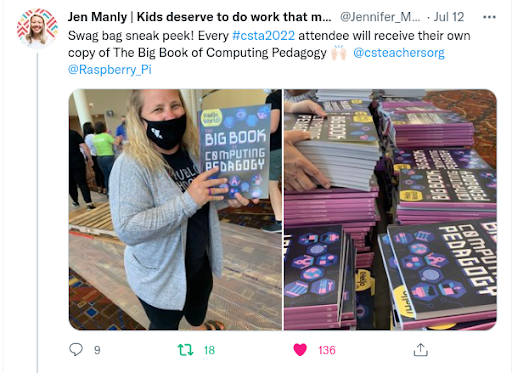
[[17, 8, 59, 49]]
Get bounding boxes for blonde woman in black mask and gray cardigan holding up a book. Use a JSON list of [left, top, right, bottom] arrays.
[[109, 90, 258, 330]]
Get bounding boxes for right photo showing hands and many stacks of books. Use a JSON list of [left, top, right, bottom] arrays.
[[283, 88, 497, 331]]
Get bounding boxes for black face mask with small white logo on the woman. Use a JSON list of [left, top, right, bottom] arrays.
[[142, 114, 187, 150]]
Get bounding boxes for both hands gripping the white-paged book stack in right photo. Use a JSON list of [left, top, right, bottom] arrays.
[[283, 100, 331, 192]]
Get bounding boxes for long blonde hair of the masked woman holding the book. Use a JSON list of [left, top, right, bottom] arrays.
[[124, 89, 199, 173]]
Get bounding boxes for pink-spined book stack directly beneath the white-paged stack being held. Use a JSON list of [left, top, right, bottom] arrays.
[[284, 176, 380, 253]]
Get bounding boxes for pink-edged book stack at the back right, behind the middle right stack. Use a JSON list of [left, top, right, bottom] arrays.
[[385, 112, 474, 149]]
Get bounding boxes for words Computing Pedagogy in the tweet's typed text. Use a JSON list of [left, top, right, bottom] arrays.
[[205, 47, 327, 60]]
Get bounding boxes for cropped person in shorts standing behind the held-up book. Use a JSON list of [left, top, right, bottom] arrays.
[[261, 90, 283, 233]]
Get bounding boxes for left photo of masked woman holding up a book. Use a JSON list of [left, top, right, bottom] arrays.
[[68, 89, 282, 331]]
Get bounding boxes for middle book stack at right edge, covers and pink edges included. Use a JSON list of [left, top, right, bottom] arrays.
[[396, 169, 497, 225]]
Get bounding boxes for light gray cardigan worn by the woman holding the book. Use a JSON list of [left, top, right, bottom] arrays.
[[109, 154, 227, 310]]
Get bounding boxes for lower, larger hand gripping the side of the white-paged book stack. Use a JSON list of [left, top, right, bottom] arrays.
[[283, 131, 331, 192]]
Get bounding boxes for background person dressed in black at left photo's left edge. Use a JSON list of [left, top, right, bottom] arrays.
[[69, 129, 94, 210]]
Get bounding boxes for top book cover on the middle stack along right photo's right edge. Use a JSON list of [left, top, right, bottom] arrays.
[[399, 169, 498, 210]]
